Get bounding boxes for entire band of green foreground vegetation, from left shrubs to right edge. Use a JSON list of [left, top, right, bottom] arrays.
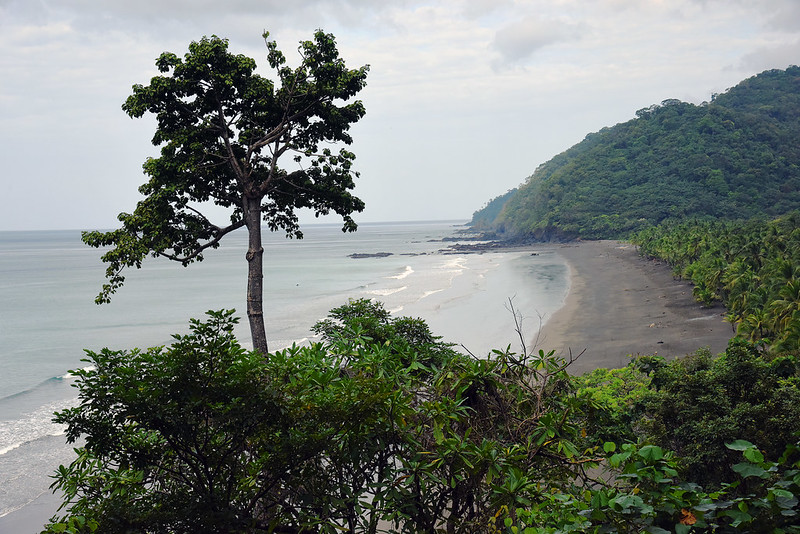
[[46, 300, 800, 534]]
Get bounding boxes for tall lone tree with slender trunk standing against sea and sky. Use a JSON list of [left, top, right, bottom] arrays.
[[82, 30, 368, 353]]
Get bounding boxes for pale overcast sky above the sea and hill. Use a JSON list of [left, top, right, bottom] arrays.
[[0, 0, 800, 231]]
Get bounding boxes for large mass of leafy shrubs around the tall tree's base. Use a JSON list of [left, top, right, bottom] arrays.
[[49, 301, 586, 534]]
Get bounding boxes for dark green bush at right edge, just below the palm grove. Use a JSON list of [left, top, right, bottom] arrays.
[[635, 339, 800, 487]]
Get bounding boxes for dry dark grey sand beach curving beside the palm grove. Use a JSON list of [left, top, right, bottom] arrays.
[[537, 241, 733, 374]]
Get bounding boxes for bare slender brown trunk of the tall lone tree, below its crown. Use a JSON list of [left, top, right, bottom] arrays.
[[243, 197, 268, 355]]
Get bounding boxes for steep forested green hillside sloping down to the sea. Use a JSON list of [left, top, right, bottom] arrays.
[[473, 66, 800, 239]]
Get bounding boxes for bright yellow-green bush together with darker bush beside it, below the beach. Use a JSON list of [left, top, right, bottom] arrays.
[[575, 339, 800, 488]]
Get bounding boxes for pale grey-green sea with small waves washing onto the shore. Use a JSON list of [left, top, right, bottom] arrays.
[[0, 221, 569, 534]]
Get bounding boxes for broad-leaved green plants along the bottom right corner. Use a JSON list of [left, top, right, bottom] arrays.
[[504, 440, 800, 534]]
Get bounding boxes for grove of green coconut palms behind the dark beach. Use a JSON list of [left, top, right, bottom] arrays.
[[633, 212, 800, 352]]
